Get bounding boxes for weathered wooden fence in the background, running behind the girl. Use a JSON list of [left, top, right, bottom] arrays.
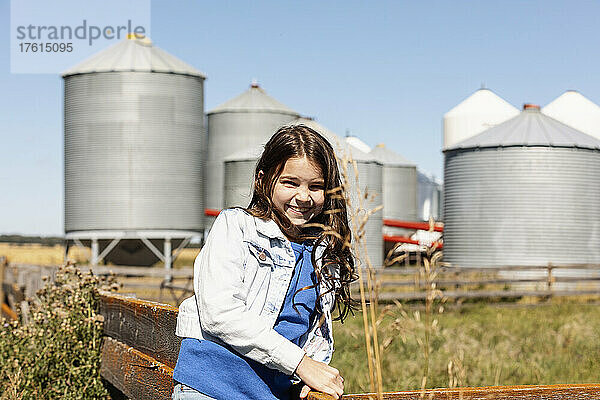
[[3, 264, 600, 309]]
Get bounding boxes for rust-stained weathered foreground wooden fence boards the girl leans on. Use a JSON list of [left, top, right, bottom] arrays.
[[100, 292, 600, 400]]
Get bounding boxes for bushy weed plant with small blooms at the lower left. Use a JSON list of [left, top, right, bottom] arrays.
[[0, 265, 116, 400]]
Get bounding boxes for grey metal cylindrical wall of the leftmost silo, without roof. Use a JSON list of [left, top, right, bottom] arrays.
[[65, 72, 206, 232]]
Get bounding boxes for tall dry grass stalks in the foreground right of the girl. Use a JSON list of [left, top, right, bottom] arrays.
[[339, 143, 448, 400]]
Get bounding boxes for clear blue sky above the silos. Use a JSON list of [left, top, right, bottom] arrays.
[[0, 0, 600, 235]]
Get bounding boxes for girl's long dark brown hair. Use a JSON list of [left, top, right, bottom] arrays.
[[246, 125, 357, 321]]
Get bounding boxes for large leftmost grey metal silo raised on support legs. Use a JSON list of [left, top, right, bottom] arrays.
[[63, 34, 206, 267]]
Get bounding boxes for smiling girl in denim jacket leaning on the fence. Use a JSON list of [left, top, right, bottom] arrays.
[[173, 125, 356, 400]]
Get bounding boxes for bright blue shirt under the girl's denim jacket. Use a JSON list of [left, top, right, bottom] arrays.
[[173, 243, 318, 400]]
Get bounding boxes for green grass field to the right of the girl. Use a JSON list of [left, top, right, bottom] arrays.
[[332, 302, 600, 393]]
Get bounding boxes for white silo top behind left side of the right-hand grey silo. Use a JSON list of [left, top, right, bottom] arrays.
[[443, 88, 519, 149]]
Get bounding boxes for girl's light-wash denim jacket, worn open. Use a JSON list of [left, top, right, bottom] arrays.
[[175, 209, 337, 375]]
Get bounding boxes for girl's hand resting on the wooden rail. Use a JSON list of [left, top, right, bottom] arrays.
[[296, 355, 344, 399]]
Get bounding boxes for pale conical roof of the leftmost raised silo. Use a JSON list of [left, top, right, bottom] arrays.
[[62, 35, 206, 79]]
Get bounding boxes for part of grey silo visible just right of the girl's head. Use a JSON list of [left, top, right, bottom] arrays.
[[292, 118, 384, 268]]
